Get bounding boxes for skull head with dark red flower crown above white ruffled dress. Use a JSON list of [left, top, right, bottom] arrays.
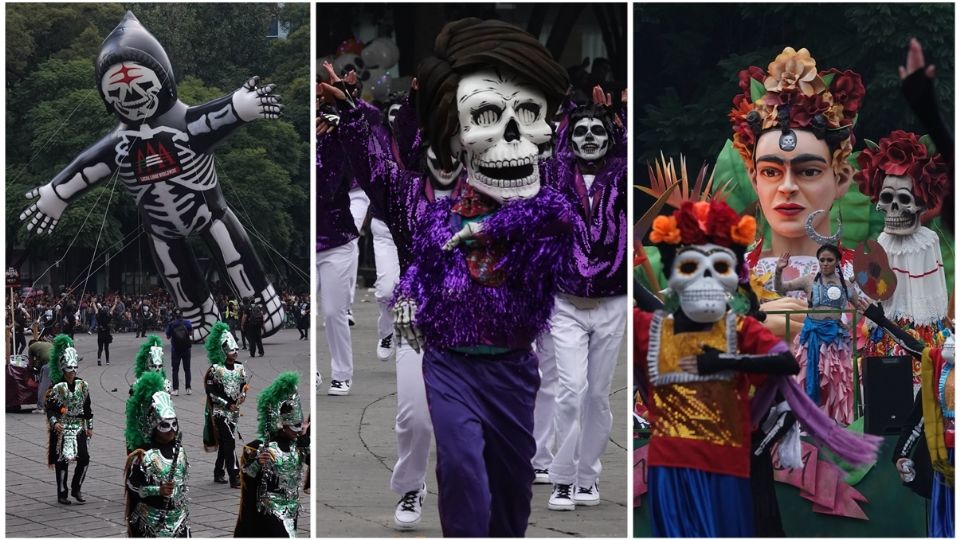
[[854, 130, 949, 236]]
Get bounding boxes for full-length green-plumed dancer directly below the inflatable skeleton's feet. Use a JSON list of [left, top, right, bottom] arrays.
[[203, 322, 248, 488]]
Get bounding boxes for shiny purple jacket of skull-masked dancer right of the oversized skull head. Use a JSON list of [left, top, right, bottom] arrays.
[[542, 154, 628, 298]]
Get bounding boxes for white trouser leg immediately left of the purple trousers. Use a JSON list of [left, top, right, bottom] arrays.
[[390, 341, 433, 495]]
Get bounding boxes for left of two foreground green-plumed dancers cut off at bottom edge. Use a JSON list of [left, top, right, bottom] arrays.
[[124, 371, 190, 538]]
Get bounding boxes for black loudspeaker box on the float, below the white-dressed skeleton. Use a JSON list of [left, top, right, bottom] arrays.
[[862, 356, 913, 435]]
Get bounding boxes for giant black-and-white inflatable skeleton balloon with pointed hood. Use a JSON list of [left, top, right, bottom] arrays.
[[20, 12, 283, 341]]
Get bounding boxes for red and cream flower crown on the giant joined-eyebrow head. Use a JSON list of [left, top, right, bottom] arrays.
[[729, 47, 865, 174]]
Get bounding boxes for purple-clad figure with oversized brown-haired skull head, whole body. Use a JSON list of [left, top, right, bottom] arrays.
[[342, 19, 571, 537]]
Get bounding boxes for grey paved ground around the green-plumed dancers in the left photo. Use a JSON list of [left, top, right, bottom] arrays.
[[6, 324, 317, 537]]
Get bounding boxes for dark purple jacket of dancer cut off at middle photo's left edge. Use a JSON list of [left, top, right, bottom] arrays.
[[316, 130, 359, 252]]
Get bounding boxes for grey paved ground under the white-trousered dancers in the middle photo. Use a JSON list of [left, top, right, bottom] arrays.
[[314, 288, 630, 537]]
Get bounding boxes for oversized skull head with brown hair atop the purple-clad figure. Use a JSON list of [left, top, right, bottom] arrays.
[[417, 18, 569, 202]]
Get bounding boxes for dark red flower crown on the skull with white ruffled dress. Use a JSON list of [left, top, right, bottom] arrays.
[[853, 130, 949, 215]]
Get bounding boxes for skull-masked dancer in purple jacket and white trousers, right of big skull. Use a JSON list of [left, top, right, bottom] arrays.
[[534, 104, 628, 510]]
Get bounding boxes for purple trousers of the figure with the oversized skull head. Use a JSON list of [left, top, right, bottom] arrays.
[[423, 347, 540, 537]]
